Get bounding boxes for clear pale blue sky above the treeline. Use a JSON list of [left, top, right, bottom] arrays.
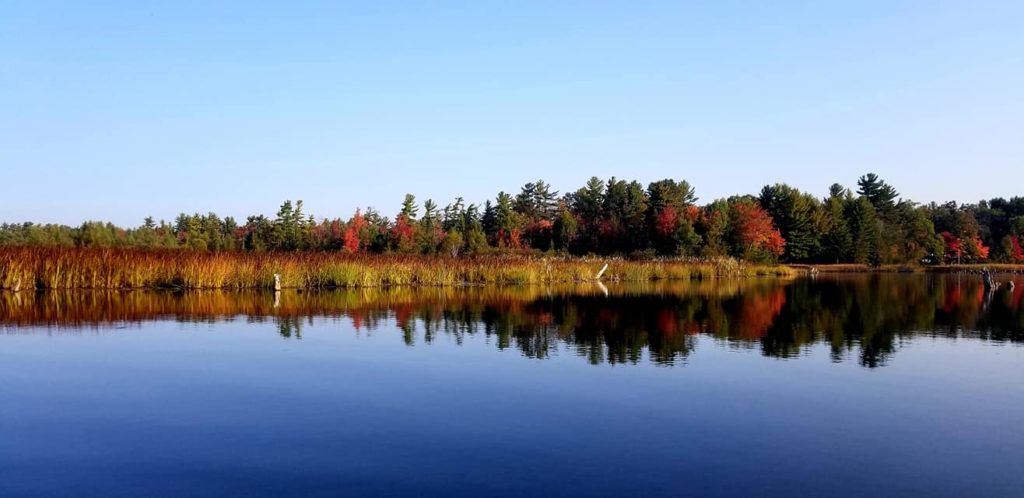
[[0, 0, 1024, 225]]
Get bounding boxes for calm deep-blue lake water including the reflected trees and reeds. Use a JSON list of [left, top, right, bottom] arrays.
[[0, 276, 1024, 497]]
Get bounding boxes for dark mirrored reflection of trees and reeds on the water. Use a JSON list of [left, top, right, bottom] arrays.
[[0, 275, 1024, 367]]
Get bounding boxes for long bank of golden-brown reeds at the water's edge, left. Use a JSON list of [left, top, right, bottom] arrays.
[[0, 248, 797, 290]]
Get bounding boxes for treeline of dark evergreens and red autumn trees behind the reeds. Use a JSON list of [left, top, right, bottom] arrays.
[[0, 173, 1024, 264]]
